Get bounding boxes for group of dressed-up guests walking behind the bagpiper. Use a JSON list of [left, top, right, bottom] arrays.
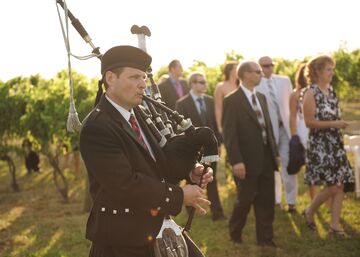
[[159, 55, 354, 247]]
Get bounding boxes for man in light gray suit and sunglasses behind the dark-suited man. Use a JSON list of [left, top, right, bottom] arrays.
[[257, 56, 298, 212]]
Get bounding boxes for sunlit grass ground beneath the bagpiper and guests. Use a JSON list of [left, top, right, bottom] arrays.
[[0, 149, 360, 257]]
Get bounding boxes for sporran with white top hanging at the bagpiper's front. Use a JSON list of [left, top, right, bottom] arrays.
[[154, 218, 205, 257]]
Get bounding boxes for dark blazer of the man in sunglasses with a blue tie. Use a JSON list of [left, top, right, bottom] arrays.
[[175, 93, 222, 144]]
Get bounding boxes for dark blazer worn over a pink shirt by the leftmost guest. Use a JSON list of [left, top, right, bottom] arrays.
[[159, 78, 189, 110]]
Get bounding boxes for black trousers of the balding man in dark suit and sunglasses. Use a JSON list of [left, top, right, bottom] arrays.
[[229, 147, 275, 243]]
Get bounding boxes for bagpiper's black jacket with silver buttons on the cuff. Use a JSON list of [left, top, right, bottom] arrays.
[[80, 95, 189, 247]]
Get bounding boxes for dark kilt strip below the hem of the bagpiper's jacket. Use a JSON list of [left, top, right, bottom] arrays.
[[89, 243, 154, 257]]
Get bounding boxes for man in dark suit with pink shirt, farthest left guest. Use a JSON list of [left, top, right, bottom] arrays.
[[159, 60, 189, 110]]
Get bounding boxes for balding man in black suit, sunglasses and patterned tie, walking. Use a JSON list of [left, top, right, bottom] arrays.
[[223, 61, 278, 247]]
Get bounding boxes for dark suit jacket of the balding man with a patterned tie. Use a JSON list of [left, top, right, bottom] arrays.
[[222, 87, 279, 176]]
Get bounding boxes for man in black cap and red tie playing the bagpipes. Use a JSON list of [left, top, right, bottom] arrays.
[[80, 46, 212, 257]]
